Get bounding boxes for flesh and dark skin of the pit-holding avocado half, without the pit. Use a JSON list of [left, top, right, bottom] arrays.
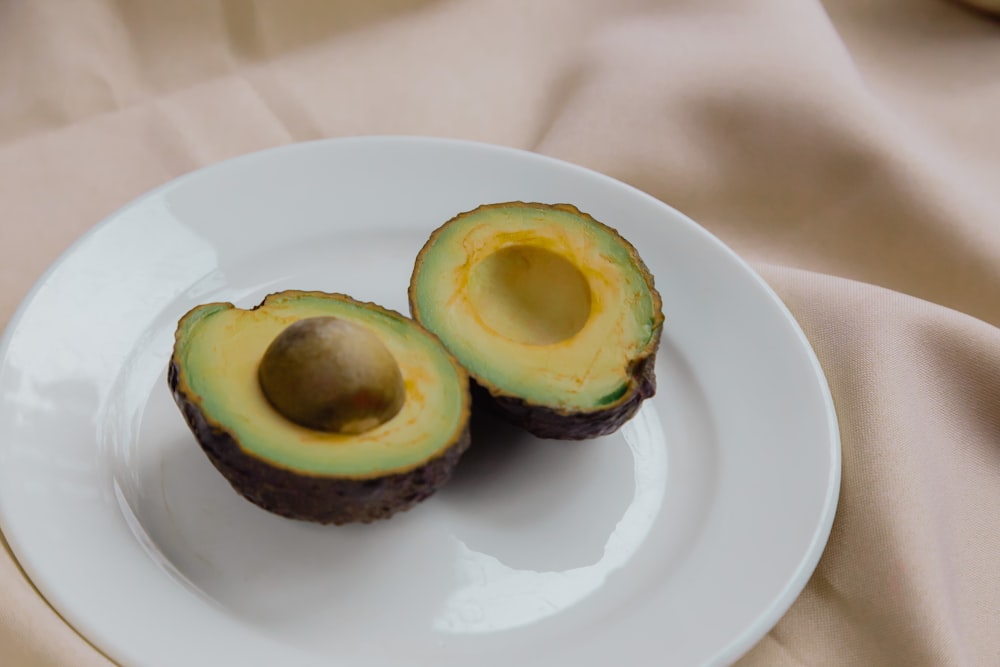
[[168, 291, 470, 523]]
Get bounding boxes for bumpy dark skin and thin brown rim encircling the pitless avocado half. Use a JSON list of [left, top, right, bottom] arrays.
[[408, 202, 663, 440]]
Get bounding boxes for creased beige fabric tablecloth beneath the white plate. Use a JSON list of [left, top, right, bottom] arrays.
[[0, 0, 1000, 667]]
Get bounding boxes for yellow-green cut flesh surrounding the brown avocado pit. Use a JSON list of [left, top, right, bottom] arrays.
[[175, 293, 467, 478]]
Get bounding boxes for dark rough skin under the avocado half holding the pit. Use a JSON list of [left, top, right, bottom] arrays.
[[167, 360, 469, 525]]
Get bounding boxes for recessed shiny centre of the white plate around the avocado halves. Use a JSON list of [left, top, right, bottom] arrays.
[[106, 238, 715, 664]]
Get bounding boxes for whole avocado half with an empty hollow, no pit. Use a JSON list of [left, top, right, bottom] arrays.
[[409, 202, 663, 439]]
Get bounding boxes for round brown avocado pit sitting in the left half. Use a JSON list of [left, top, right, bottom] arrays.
[[258, 316, 406, 434]]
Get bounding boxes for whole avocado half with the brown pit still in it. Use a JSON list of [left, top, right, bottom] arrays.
[[168, 291, 471, 524]]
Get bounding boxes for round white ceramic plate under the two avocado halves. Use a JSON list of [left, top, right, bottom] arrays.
[[0, 137, 840, 667]]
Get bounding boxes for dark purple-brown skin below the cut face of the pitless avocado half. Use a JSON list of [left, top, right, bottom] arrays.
[[470, 331, 660, 440]]
